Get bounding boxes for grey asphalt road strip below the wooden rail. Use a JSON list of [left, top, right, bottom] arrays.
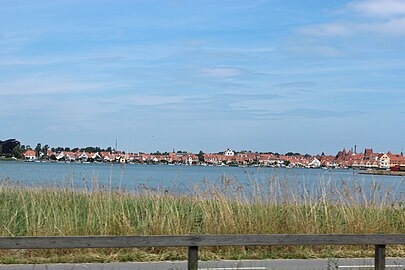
[[0, 258, 405, 270]]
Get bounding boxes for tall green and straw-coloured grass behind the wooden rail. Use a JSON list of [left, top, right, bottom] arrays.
[[0, 173, 405, 263]]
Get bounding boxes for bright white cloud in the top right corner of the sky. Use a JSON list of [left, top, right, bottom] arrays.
[[348, 0, 405, 18]]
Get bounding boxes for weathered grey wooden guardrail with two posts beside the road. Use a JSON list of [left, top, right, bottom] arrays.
[[0, 234, 405, 270]]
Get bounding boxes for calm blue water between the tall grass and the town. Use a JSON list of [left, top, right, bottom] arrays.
[[0, 161, 405, 196]]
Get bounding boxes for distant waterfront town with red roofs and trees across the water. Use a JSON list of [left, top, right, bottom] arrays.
[[0, 139, 405, 171]]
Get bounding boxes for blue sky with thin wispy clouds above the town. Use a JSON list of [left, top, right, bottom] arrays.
[[0, 0, 405, 154]]
